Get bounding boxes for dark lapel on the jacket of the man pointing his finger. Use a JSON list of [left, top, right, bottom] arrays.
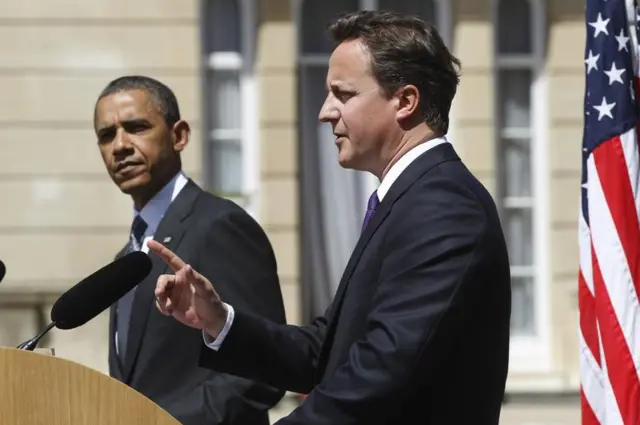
[[316, 143, 460, 377]]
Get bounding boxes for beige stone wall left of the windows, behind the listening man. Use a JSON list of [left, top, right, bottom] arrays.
[[0, 0, 201, 371]]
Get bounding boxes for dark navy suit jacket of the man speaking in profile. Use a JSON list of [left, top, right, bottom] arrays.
[[201, 143, 511, 425]]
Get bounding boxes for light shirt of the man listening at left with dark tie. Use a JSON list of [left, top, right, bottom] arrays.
[[114, 171, 188, 352]]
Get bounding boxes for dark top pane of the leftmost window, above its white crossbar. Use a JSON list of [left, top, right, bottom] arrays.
[[204, 0, 242, 53]]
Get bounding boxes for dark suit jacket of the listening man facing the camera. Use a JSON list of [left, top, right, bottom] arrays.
[[109, 181, 285, 425]]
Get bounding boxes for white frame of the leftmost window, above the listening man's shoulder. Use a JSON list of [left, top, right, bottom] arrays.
[[200, 0, 260, 218]]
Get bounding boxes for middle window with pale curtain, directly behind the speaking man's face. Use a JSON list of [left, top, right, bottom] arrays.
[[294, 0, 451, 321]]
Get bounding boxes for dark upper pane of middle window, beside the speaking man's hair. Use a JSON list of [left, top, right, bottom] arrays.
[[298, 0, 358, 54]]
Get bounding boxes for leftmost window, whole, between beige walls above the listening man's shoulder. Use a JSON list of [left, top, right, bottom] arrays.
[[202, 0, 259, 213]]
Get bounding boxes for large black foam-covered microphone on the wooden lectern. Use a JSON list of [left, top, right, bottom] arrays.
[[17, 251, 151, 351]]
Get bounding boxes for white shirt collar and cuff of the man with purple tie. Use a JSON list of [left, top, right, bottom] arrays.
[[202, 137, 449, 351]]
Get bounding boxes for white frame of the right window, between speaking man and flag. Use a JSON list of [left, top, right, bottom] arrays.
[[492, 0, 551, 373]]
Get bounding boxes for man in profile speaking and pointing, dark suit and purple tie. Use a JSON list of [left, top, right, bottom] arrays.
[[150, 11, 511, 425]]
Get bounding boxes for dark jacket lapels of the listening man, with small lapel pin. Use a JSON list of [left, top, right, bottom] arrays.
[[123, 180, 202, 382]]
